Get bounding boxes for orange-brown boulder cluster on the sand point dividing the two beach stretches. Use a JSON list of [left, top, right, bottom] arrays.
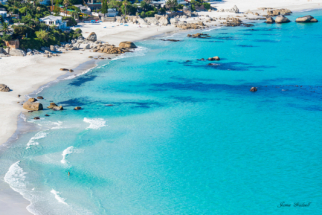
[[93, 41, 137, 54]]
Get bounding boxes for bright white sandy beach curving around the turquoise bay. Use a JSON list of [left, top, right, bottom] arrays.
[[0, 0, 322, 215]]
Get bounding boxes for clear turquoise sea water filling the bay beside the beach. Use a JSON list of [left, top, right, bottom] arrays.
[[0, 11, 322, 215]]
